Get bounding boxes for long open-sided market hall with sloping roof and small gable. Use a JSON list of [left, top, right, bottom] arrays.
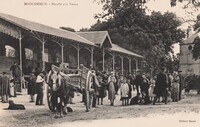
[[0, 13, 143, 78]]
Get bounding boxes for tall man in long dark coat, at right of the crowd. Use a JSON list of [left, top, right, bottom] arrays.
[[153, 67, 168, 105]]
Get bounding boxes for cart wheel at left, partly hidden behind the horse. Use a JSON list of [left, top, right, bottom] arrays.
[[47, 87, 56, 112]]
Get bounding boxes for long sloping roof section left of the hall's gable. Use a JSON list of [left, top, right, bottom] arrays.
[[0, 13, 94, 46]]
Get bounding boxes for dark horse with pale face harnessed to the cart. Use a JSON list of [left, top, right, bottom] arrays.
[[50, 72, 74, 118]]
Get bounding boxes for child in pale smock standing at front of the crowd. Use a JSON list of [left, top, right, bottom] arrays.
[[120, 77, 129, 106]]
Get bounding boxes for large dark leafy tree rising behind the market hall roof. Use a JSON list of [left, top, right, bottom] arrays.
[[90, 0, 185, 72]]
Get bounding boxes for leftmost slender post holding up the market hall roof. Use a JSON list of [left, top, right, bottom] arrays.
[[19, 31, 22, 91]]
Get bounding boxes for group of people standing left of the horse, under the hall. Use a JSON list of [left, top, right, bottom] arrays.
[[0, 62, 46, 105]]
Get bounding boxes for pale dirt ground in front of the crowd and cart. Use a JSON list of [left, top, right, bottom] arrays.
[[0, 90, 200, 127]]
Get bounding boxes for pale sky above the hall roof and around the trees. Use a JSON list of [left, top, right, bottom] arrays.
[[0, 0, 198, 52]]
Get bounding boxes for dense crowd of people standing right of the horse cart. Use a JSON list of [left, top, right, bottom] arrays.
[[93, 67, 182, 107]]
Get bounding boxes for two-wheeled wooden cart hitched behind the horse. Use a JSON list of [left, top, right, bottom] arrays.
[[47, 65, 92, 112]]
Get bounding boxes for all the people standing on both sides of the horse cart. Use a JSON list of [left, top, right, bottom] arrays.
[[0, 63, 182, 107]]
